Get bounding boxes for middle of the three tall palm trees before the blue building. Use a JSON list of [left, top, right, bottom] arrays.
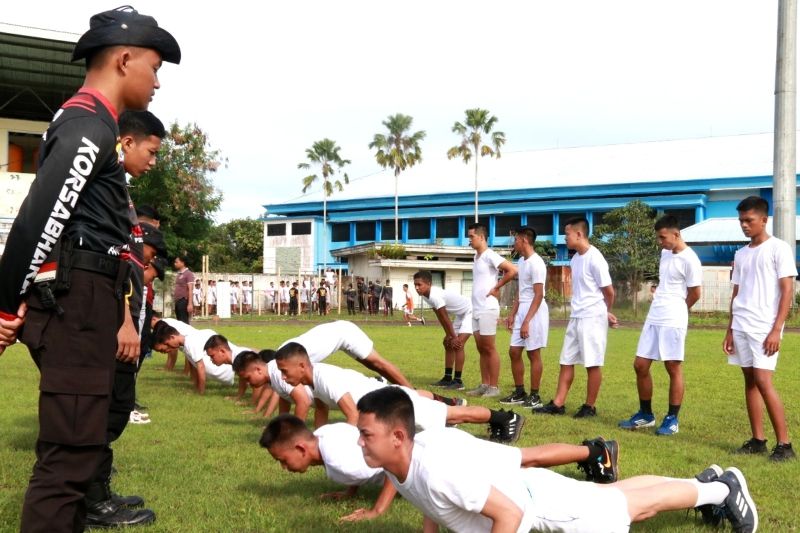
[[369, 113, 425, 244]]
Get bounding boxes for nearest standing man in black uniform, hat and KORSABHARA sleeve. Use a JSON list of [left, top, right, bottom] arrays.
[[0, 7, 180, 533]]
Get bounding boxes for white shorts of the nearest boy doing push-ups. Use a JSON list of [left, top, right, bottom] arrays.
[[518, 468, 631, 533]]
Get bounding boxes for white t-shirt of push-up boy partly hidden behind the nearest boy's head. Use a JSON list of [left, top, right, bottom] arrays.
[[314, 422, 384, 487]]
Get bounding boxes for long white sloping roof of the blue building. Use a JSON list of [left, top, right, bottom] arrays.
[[265, 133, 788, 211]]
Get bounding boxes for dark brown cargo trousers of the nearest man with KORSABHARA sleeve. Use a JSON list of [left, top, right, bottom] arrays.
[[20, 270, 124, 533]]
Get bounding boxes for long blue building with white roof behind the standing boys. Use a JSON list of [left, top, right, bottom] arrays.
[[263, 133, 800, 275]]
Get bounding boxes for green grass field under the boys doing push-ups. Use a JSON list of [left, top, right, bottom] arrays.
[[0, 322, 800, 533]]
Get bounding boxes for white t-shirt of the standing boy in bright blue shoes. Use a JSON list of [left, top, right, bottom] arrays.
[[645, 246, 703, 328]]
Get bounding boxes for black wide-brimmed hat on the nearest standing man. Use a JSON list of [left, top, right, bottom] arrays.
[[72, 6, 181, 63]]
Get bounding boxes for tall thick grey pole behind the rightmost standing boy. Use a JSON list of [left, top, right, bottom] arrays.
[[772, 0, 797, 257]]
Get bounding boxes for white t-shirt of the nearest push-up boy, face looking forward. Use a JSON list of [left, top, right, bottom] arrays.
[[386, 428, 531, 533]]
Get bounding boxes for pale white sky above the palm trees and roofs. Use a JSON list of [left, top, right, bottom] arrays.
[[0, 0, 792, 222]]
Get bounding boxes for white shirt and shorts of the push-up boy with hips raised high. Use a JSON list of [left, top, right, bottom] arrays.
[[278, 320, 373, 363]]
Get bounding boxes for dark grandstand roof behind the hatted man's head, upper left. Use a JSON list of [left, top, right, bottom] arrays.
[[0, 22, 86, 122]]
